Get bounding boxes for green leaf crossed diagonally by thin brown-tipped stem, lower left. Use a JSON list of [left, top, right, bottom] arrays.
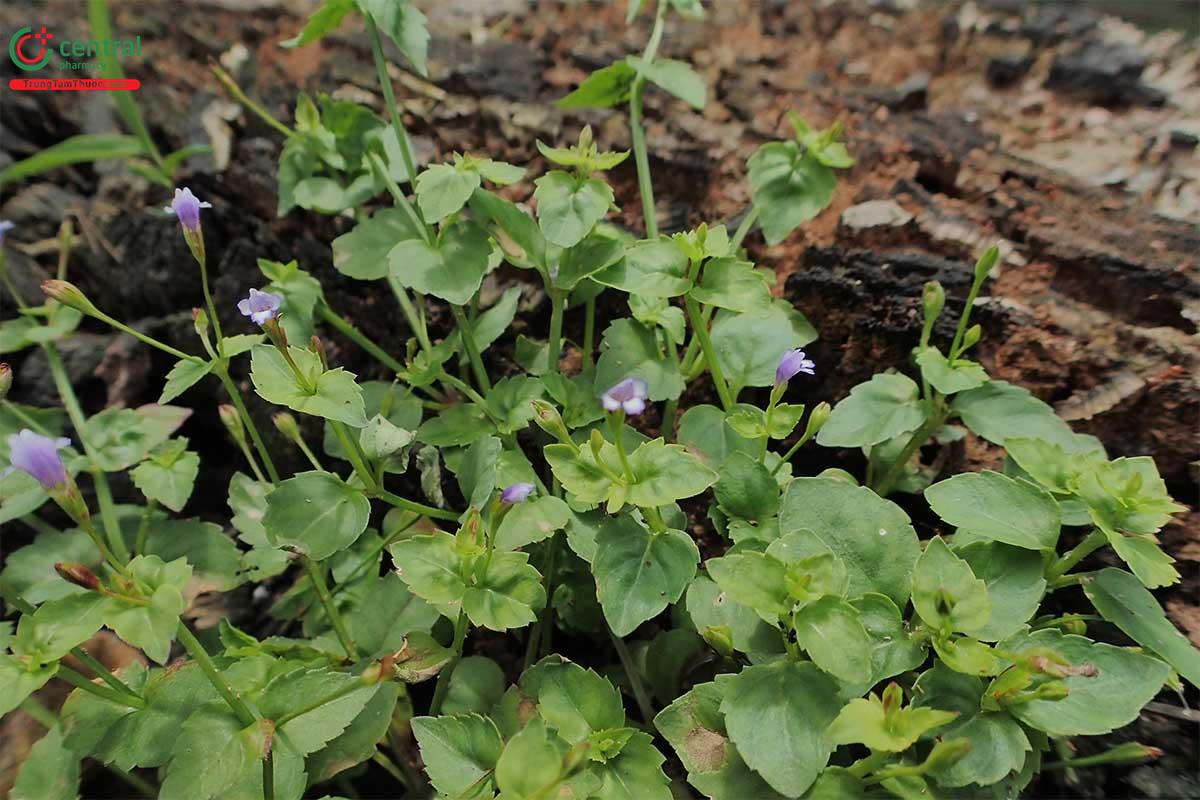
[[258, 669, 379, 756]]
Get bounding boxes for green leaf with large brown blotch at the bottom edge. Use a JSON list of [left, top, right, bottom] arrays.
[[654, 682, 784, 800]]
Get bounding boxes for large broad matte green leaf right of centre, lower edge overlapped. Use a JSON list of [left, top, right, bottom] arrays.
[[779, 477, 920, 607]]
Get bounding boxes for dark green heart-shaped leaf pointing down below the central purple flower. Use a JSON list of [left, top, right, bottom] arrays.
[[592, 516, 700, 636]]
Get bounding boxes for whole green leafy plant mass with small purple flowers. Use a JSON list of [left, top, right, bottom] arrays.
[[0, 0, 1200, 800]]
